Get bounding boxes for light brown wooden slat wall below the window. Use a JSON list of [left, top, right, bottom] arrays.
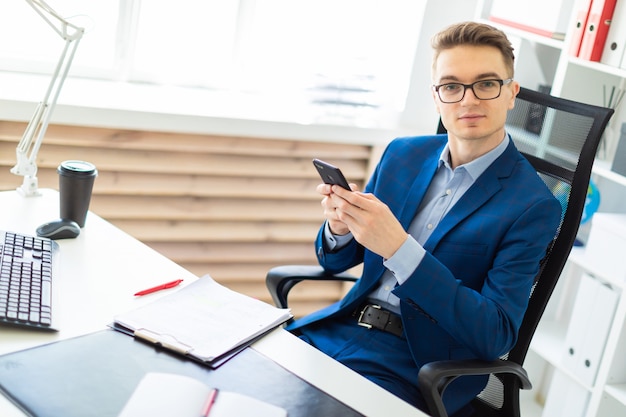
[[0, 121, 372, 315]]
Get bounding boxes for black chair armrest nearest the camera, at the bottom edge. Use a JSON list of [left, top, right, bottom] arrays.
[[418, 359, 532, 417]]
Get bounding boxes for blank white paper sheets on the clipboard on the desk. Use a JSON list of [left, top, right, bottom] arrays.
[[114, 275, 292, 362]]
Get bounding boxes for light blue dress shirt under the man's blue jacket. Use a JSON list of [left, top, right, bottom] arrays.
[[324, 135, 510, 313]]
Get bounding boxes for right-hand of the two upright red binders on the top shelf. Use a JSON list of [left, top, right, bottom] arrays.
[[578, 0, 617, 62]]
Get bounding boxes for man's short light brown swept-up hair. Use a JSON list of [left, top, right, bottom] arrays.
[[431, 22, 515, 77]]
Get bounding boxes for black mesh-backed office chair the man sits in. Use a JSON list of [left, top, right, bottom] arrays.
[[266, 88, 613, 417]]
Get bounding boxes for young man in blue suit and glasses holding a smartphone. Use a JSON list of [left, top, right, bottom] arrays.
[[288, 22, 561, 414]]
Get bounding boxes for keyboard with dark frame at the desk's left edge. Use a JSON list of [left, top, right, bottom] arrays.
[[0, 231, 59, 331]]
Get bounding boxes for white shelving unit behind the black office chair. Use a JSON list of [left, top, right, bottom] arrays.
[[474, 0, 626, 417]]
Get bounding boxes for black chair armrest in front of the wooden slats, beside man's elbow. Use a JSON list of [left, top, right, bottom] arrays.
[[265, 265, 357, 308]]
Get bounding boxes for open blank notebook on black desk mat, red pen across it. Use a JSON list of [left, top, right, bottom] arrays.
[[119, 372, 287, 417]]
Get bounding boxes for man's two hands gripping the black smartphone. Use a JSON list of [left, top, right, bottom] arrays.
[[317, 184, 407, 259]]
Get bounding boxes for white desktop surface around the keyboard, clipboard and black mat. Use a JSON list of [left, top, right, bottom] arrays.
[[0, 190, 426, 417]]
